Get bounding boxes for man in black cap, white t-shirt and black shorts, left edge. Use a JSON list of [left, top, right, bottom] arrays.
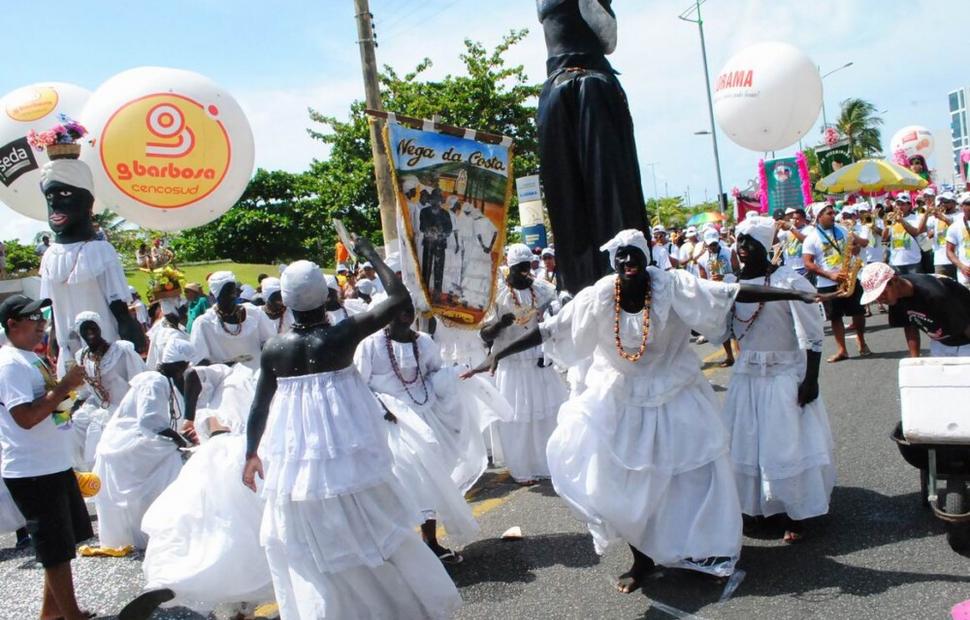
[[0, 295, 94, 620]]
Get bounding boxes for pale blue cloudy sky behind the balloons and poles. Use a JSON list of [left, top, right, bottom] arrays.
[[0, 0, 970, 239]]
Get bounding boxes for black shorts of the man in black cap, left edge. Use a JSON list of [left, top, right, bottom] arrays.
[[3, 469, 94, 568]]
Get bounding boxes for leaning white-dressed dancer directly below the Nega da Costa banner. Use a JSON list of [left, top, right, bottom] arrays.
[[354, 305, 487, 563]]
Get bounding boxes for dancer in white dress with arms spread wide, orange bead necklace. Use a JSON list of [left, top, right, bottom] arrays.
[[473, 230, 814, 592]]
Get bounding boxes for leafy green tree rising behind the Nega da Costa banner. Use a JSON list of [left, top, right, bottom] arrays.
[[308, 30, 541, 248]]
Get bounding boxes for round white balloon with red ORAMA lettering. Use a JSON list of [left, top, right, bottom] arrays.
[[714, 42, 822, 151]]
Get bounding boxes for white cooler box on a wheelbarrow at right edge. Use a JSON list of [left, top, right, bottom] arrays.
[[899, 357, 970, 443]]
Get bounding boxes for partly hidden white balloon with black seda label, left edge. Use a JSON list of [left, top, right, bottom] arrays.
[[0, 82, 91, 222]]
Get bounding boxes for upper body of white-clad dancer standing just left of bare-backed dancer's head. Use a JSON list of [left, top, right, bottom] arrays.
[[191, 271, 276, 370]]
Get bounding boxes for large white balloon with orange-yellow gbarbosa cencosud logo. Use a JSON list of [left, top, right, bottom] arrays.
[[81, 67, 254, 231]]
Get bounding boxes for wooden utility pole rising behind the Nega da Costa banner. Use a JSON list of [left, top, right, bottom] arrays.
[[354, 0, 397, 253]]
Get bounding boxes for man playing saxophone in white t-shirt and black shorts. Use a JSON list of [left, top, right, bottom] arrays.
[[802, 205, 872, 364]]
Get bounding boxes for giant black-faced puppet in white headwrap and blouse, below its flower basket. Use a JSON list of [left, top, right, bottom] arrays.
[[40, 153, 145, 376]]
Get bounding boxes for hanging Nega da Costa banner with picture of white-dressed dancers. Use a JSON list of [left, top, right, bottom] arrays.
[[384, 117, 512, 328]]
